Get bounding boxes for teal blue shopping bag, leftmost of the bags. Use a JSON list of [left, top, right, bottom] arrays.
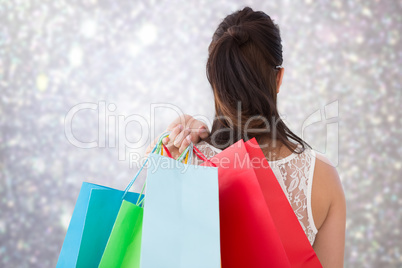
[[57, 182, 139, 268]]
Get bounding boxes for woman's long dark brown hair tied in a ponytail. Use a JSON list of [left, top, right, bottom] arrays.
[[206, 7, 310, 153]]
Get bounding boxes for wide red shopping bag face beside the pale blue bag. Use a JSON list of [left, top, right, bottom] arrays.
[[203, 140, 291, 268]]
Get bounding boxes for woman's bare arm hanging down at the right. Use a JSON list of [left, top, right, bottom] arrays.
[[311, 154, 346, 268]]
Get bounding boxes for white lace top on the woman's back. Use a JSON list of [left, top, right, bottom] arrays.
[[192, 141, 317, 245]]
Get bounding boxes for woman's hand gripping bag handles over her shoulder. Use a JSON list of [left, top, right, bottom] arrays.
[[145, 114, 209, 159]]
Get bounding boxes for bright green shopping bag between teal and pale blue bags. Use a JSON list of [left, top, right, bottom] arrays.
[[99, 200, 144, 268]]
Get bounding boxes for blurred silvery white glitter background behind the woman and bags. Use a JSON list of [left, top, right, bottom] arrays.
[[0, 0, 402, 268]]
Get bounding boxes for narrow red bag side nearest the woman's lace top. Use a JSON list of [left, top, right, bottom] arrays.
[[245, 138, 322, 268]]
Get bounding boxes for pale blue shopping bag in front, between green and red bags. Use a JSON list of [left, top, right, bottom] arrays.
[[140, 149, 221, 268]]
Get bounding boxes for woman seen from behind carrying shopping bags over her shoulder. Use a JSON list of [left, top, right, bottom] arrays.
[[148, 7, 346, 268]]
